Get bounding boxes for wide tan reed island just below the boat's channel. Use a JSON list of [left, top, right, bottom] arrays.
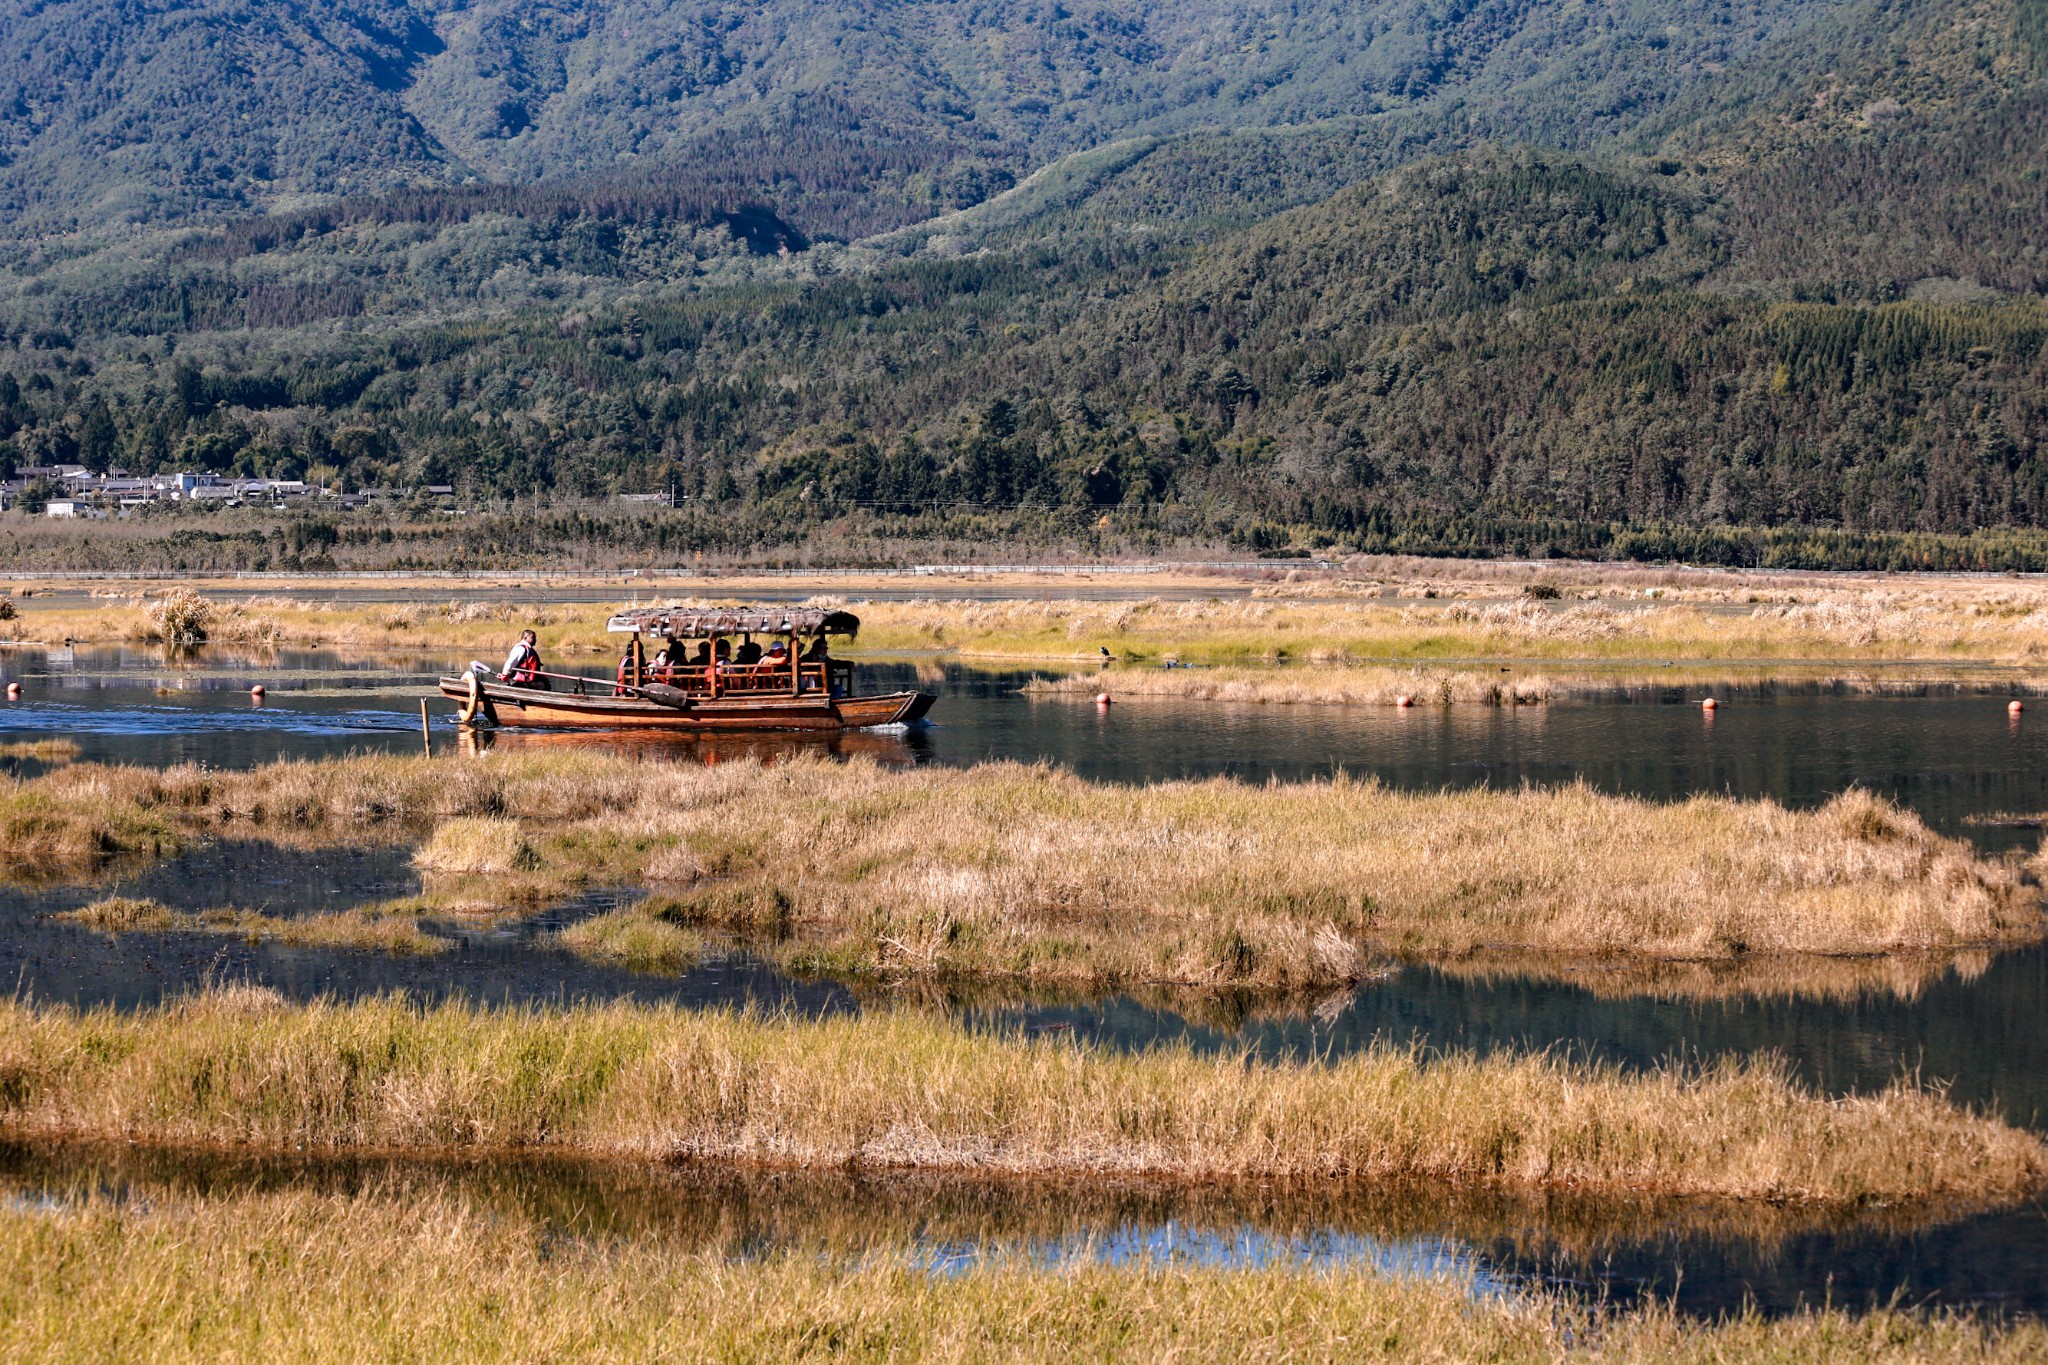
[[12, 751, 2048, 988]]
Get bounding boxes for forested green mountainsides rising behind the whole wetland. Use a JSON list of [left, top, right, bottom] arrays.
[[0, 0, 2048, 567]]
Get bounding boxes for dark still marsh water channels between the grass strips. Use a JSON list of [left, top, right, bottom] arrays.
[[12, 649, 2048, 1314]]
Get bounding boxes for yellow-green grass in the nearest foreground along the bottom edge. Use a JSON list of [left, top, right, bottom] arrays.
[[0, 1189, 2048, 1365]]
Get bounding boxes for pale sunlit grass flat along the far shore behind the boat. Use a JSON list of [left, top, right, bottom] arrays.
[[10, 577, 2048, 665]]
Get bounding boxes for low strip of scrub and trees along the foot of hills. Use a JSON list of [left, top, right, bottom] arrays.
[[12, 503, 2048, 573]]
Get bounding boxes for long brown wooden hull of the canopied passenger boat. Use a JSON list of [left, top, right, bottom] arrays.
[[440, 677, 938, 733]]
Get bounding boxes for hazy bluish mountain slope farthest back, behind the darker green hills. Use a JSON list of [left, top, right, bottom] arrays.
[[0, 0, 1829, 227]]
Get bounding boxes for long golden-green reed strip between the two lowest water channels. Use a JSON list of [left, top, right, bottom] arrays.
[[0, 997, 2048, 1203]]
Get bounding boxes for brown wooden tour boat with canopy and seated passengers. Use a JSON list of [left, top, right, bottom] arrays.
[[440, 606, 938, 733]]
